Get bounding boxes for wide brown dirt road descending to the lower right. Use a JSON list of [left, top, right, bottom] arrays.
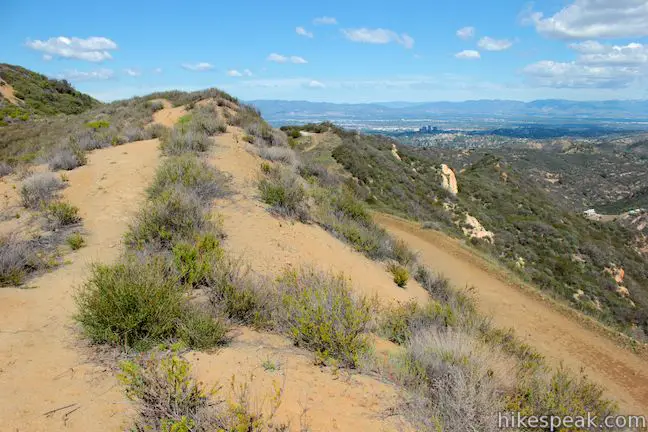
[[375, 214, 648, 414]]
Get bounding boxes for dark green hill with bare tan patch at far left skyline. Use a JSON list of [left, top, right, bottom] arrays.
[[0, 63, 100, 126]]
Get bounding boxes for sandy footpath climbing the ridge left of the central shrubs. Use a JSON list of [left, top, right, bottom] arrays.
[[0, 140, 158, 432]]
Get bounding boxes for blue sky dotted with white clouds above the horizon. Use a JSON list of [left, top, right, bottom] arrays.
[[0, 0, 648, 102]]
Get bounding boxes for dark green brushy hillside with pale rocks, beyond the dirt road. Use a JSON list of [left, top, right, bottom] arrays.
[[324, 125, 648, 340]]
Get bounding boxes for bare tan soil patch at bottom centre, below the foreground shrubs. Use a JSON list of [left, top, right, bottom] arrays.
[[188, 328, 408, 431]]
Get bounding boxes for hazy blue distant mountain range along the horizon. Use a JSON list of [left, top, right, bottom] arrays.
[[249, 99, 648, 122]]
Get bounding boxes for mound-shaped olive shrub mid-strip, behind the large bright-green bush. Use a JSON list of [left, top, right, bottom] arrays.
[[126, 188, 211, 249]]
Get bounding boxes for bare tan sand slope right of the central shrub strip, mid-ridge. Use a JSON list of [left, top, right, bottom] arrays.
[[211, 128, 428, 301]]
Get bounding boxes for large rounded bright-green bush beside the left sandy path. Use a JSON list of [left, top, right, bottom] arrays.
[[76, 257, 186, 348]]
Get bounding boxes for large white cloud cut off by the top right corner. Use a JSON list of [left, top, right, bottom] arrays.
[[525, 0, 648, 39]]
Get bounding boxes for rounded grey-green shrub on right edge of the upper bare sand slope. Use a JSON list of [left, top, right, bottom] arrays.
[[259, 167, 309, 222]]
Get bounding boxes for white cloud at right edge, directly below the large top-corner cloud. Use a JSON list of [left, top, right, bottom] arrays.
[[569, 41, 648, 66]]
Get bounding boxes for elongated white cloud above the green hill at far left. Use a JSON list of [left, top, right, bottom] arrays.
[[26, 36, 117, 62]]
